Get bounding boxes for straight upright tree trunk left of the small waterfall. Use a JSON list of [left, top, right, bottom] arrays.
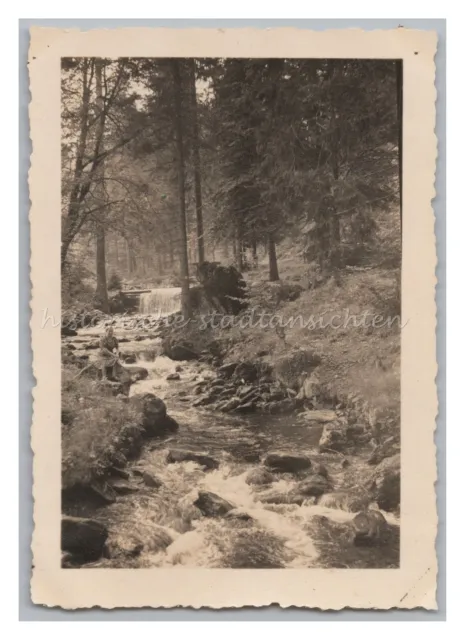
[[95, 58, 110, 313]]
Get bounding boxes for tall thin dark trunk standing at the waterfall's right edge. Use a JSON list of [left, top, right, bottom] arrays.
[[171, 59, 191, 319]]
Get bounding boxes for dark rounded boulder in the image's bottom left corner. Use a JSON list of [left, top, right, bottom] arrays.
[[61, 516, 108, 563]]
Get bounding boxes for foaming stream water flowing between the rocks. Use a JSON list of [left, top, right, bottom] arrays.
[[66, 308, 399, 568]]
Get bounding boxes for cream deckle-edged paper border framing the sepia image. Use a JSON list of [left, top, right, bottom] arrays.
[[29, 27, 437, 609]]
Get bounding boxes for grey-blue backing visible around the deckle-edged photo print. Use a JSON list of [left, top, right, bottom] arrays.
[[19, 18, 446, 622]]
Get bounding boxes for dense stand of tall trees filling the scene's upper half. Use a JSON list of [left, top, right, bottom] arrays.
[[61, 58, 402, 312]]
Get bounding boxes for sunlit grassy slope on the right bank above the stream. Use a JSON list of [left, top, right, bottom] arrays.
[[205, 256, 401, 437]]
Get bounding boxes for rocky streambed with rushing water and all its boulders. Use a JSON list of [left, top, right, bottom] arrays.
[[62, 318, 400, 568]]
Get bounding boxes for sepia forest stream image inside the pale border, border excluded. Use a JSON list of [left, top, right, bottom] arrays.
[[61, 57, 403, 569]]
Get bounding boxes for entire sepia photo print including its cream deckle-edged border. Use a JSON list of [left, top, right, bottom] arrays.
[[28, 22, 438, 611]]
